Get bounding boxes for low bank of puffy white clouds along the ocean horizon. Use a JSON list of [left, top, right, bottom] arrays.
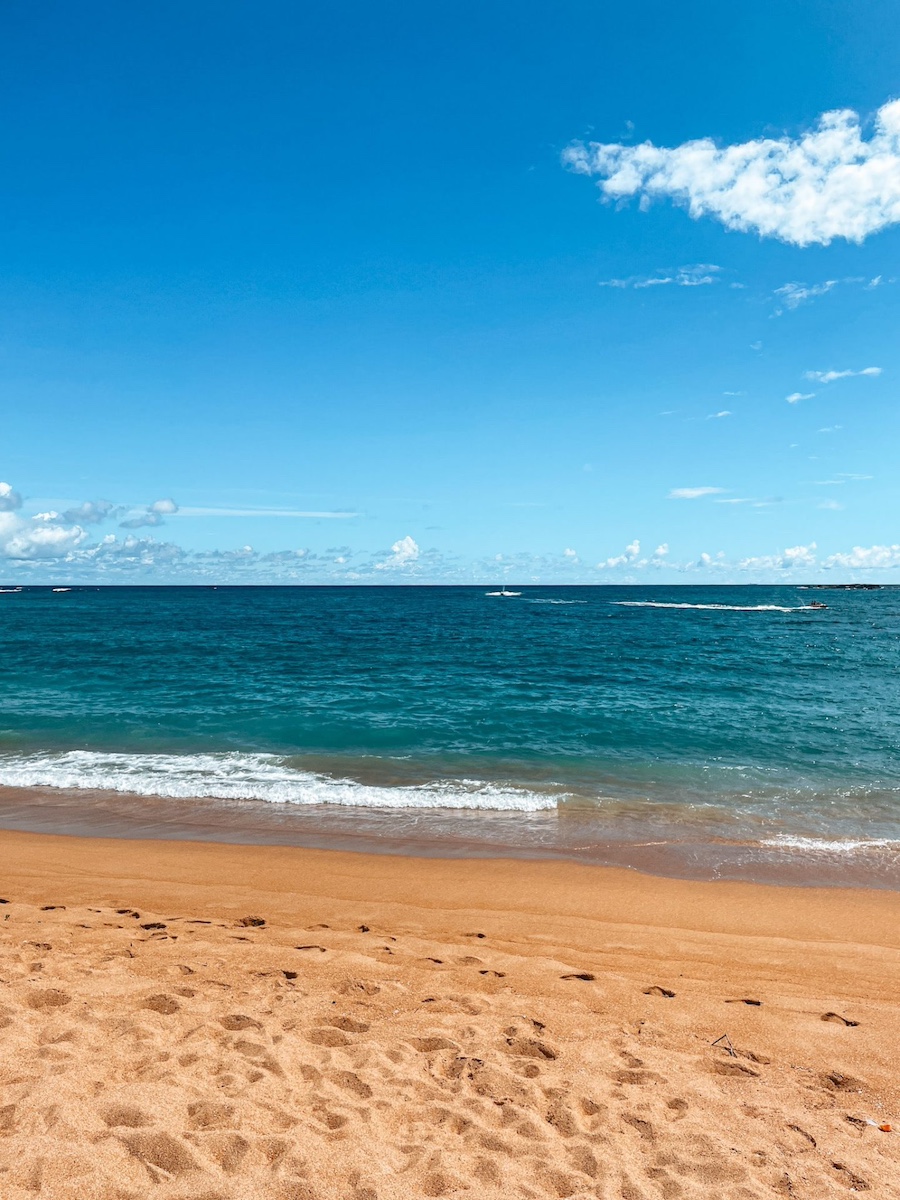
[[0, 475, 900, 584]]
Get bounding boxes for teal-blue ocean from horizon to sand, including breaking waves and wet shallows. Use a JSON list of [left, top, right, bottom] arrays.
[[0, 587, 900, 887]]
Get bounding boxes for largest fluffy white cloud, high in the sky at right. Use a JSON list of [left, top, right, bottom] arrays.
[[563, 101, 900, 246]]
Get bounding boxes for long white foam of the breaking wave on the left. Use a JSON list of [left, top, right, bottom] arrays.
[[0, 750, 557, 812]]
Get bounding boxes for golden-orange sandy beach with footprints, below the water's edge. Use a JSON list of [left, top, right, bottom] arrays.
[[0, 832, 900, 1200]]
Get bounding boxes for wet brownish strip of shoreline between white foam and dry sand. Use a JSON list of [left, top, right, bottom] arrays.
[[0, 786, 900, 892]]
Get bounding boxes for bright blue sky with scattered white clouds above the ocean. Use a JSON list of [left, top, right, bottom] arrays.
[[0, 0, 900, 586]]
